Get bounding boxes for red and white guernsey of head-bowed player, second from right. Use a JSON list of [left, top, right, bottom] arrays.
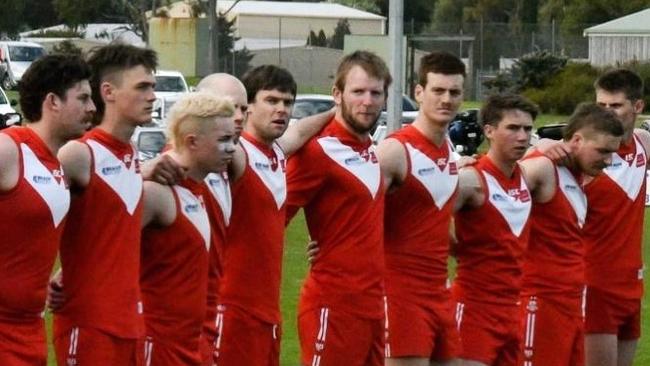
[[522, 152, 587, 316]]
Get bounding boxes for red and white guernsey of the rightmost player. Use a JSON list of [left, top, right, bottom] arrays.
[[584, 136, 648, 299]]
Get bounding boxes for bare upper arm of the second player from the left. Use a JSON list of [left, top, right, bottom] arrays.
[[58, 141, 91, 192]]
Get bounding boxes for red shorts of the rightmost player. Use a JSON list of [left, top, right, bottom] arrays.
[[585, 287, 641, 340]]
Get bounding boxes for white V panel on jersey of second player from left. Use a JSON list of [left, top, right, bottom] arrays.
[[86, 140, 142, 215]]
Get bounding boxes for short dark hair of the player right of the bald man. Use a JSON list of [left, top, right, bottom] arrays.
[[241, 65, 298, 103]]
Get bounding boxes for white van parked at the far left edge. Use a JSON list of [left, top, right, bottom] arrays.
[[0, 41, 45, 90]]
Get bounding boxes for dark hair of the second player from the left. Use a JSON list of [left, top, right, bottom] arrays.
[[88, 43, 158, 122]]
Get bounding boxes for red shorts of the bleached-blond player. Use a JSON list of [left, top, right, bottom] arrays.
[[139, 337, 201, 366]]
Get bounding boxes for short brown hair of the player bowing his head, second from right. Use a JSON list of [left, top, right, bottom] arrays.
[[564, 103, 623, 141]]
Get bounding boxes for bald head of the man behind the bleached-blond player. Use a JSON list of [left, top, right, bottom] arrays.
[[196, 73, 248, 135]]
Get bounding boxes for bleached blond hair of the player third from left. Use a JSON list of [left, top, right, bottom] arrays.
[[167, 92, 235, 150]]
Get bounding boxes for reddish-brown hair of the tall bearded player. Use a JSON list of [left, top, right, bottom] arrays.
[[334, 50, 393, 94]]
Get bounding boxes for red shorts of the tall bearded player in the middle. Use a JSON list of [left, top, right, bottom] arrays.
[[298, 307, 385, 366]]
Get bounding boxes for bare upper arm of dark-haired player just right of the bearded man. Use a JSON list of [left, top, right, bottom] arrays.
[[377, 138, 408, 192]]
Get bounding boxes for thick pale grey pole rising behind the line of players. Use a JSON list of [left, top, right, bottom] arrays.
[[386, 0, 404, 133]]
